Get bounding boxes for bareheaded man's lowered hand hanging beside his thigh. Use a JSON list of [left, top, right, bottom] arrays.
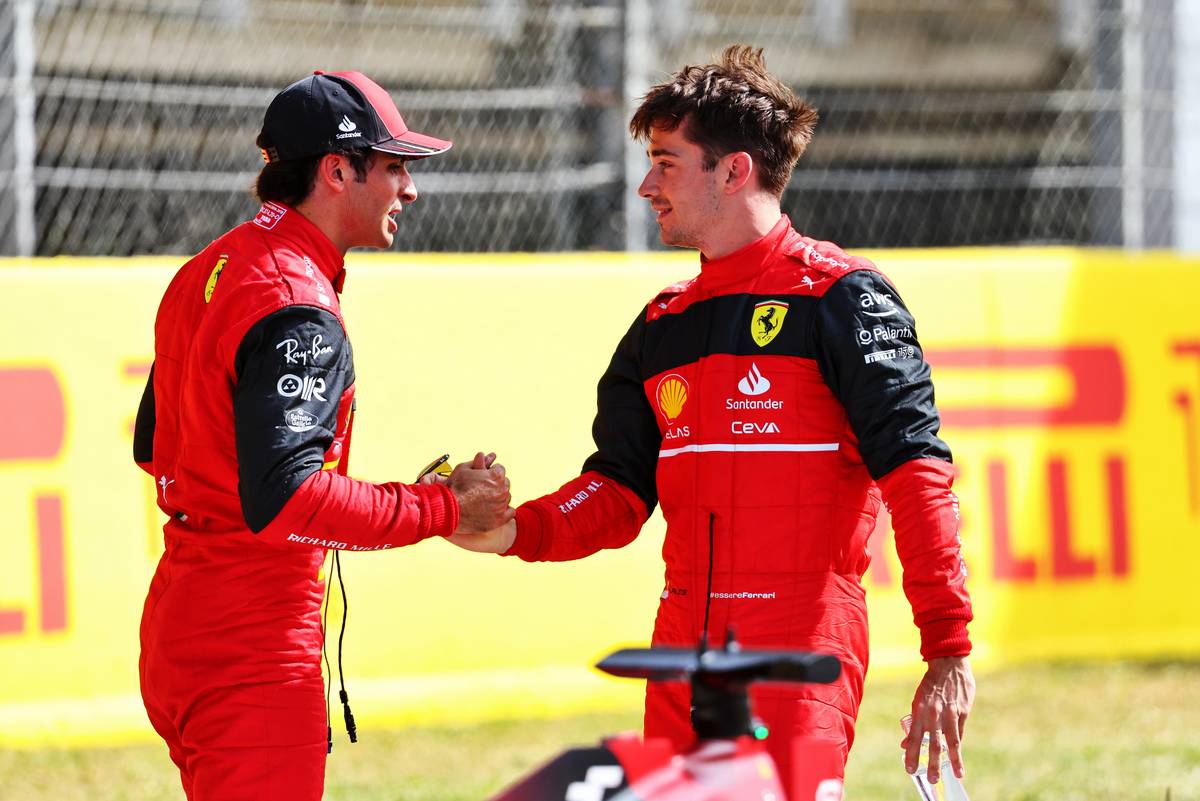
[[900, 656, 974, 783]]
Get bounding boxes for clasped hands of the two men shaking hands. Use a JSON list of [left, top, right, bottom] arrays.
[[418, 452, 517, 554]]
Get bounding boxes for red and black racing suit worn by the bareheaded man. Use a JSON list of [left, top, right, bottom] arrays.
[[506, 217, 971, 787]]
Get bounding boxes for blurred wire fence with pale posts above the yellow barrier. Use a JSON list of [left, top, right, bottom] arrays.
[[0, 0, 1176, 254]]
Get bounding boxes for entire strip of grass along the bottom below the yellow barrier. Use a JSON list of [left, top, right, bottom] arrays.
[[0, 663, 1200, 801]]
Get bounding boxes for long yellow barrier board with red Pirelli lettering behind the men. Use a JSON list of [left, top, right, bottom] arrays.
[[0, 248, 1200, 747]]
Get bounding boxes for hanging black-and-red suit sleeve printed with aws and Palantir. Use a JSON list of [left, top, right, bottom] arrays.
[[814, 270, 972, 660]]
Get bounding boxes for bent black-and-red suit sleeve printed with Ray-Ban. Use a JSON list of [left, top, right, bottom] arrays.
[[233, 306, 458, 550]]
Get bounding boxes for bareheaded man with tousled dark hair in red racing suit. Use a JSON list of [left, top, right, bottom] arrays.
[[451, 46, 974, 791]]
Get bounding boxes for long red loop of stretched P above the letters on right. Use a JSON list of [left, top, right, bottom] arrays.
[[926, 345, 1126, 428]]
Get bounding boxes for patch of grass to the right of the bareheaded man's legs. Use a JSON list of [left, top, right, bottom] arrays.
[[847, 663, 1200, 801]]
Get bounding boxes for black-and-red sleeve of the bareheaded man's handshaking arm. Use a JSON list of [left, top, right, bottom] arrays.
[[504, 309, 662, 561]]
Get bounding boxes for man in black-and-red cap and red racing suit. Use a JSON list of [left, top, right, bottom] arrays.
[[133, 72, 512, 801]]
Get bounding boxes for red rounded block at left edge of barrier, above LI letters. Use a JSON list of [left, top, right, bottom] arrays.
[[0, 367, 66, 460]]
